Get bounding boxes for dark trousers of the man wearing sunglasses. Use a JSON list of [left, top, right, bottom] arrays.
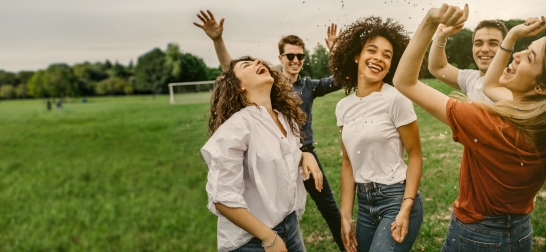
[[303, 150, 345, 251]]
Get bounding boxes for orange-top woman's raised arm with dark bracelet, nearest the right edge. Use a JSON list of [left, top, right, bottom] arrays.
[[482, 17, 546, 102]]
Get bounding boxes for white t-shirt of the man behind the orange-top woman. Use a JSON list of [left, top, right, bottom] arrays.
[[457, 69, 493, 104]]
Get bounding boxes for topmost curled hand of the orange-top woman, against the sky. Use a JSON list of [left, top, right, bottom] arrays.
[[425, 4, 468, 26]]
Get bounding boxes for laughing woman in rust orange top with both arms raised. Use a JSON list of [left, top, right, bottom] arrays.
[[393, 4, 546, 251]]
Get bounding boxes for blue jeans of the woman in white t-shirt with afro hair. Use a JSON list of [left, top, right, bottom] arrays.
[[355, 182, 423, 252]]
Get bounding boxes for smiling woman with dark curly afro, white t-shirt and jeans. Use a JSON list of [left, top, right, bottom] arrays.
[[330, 17, 423, 251]]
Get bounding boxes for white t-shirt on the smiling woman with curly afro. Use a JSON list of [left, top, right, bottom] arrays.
[[336, 84, 417, 185]]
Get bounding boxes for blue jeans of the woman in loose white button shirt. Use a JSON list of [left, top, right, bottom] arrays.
[[233, 212, 306, 252]]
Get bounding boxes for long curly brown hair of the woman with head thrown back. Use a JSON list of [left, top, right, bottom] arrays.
[[207, 56, 307, 137]]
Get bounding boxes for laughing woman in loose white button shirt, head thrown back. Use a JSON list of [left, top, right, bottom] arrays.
[[201, 57, 322, 252]]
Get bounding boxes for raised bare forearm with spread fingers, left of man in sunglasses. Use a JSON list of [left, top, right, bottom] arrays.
[[193, 10, 231, 71]]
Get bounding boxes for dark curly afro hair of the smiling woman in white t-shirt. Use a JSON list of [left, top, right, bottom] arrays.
[[329, 16, 426, 95]]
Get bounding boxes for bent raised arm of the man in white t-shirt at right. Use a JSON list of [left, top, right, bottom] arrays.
[[428, 24, 464, 89]]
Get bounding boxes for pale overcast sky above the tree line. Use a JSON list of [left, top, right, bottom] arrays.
[[0, 0, 546, 72]]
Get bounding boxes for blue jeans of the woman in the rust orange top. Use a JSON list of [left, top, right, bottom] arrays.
[[442, 214, 533, 252]]
